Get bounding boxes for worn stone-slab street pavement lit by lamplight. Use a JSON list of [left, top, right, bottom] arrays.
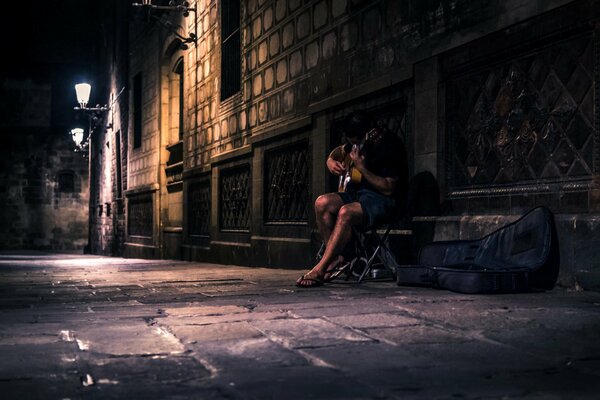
[[0, 253, 600, 399]]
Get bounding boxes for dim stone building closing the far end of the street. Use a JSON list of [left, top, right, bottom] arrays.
[[0, 88, 89, 252]]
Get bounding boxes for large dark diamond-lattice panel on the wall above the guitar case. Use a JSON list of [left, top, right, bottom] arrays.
[[446, 34, 598, 189]]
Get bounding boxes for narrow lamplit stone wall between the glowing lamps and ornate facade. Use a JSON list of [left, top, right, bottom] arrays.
[[89, 1, 129, 256]]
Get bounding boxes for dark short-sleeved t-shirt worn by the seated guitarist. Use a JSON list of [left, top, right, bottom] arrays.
[[356, 130, 408, 199]]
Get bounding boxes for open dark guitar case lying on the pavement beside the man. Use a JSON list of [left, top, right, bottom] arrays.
[[396, 207, 560, 293]]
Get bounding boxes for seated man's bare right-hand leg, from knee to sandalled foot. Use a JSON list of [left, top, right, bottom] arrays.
[[297, 202, 363, 284]]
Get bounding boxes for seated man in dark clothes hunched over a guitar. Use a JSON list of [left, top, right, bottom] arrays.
[[296, 111, 408, 288]]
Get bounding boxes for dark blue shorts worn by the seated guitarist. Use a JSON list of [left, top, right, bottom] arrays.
[[337, 189, 395, 230]]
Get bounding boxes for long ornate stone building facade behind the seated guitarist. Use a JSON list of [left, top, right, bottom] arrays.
[[93, 0, 600, 285]]
